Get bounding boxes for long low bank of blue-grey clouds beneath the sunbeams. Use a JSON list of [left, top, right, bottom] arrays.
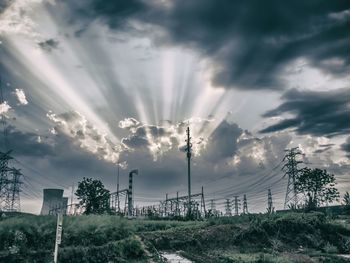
[[5, 112, 290, 202]]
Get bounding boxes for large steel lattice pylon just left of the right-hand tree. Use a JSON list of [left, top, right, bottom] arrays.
[[282, 147, 302, 209]]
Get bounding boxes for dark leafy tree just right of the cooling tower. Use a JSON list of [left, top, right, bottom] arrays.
[[75, 177, 110, 214]]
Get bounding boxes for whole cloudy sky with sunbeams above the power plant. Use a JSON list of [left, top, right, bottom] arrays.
[[0, 0, 350, 213]]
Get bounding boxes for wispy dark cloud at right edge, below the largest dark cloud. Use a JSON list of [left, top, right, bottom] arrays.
[[261, 89, 350, 137]]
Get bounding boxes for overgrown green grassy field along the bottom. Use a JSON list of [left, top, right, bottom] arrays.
[[0, 213, 350, 263]]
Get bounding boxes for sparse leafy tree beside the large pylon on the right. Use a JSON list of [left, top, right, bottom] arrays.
[[295, 167, 339, 210]]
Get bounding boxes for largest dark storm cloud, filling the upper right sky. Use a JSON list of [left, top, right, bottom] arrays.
[[67, 0, 350, 89]]
